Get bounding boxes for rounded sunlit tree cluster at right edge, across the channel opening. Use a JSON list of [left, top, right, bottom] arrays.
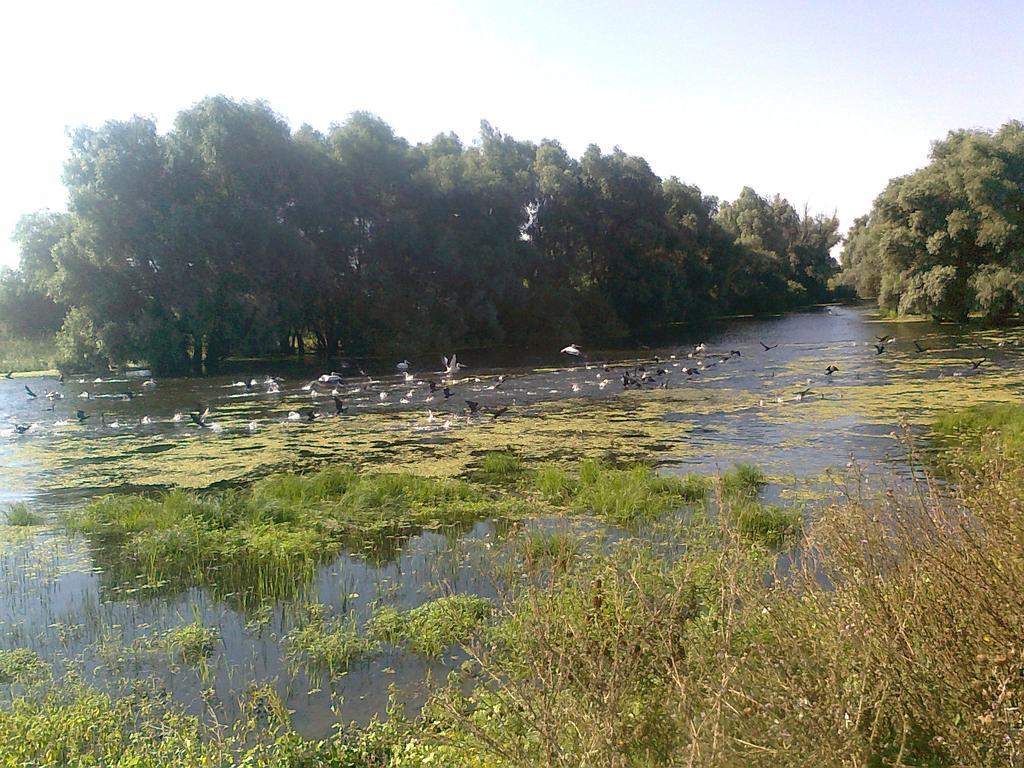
[[841, 121, 1024, 322]]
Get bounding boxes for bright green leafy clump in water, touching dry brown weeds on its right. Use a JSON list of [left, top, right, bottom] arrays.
[[368, 595, 493, 657]]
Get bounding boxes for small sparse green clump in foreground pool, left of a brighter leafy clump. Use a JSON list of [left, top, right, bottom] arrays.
[[282, 603, 376, 678]]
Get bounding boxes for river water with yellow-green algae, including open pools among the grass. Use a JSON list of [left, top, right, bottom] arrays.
[[0, 307, 1024, 735]]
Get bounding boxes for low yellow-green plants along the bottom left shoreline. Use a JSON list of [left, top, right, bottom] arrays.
[[0, 680, 436, 768]]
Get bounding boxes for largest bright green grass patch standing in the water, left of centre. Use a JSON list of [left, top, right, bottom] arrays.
[[66, 468, 524, 607]]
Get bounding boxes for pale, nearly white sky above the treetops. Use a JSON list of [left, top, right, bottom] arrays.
[[0, 0, 1024, 266]]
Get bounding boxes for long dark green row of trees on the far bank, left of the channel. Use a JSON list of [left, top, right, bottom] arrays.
[[0, 97, 839, 373]]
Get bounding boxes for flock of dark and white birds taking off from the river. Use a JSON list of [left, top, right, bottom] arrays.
[[5, 311, 1002, 435]]
